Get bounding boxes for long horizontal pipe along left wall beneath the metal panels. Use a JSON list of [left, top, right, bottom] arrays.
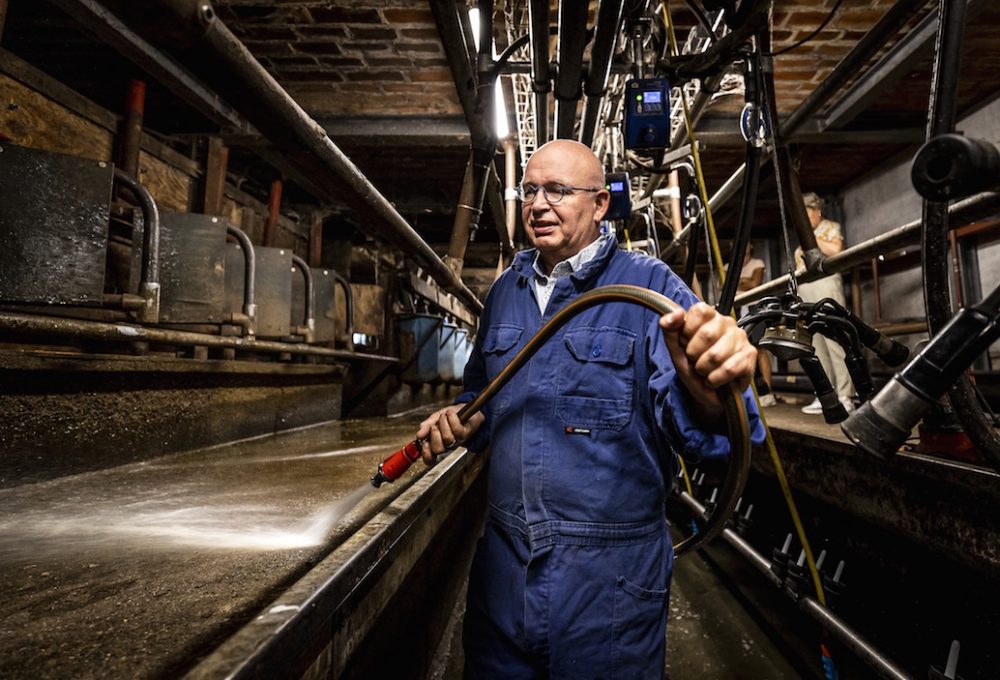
[[0, 312, 386, 362]]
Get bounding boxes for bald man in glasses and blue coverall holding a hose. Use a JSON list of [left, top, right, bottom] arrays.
[[417, 140, 763, 679]]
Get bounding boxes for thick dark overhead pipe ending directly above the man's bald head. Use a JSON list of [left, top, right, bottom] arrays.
[[555, 0, 588, 139]]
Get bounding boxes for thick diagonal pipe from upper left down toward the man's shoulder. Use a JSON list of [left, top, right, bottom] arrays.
[[125, 0, 482, 312]]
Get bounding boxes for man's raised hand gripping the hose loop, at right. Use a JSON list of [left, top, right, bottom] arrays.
[[660, 302, 757, 417]]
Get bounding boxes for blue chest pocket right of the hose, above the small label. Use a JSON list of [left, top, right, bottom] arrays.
[[556, 326, 635, 430]]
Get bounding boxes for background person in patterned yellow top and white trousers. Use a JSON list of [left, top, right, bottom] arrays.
[[795, 192, 854, 415]]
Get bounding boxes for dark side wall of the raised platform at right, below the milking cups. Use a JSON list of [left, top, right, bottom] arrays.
[[753, 404, 1000, 576]]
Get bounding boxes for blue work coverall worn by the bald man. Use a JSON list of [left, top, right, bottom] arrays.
[[458, 239, 763, 679]]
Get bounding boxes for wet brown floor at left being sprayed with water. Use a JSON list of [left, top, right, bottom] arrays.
[[0, 408, 446, 678]]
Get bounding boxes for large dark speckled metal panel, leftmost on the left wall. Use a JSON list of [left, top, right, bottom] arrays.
[[0, 144, 113, 305]]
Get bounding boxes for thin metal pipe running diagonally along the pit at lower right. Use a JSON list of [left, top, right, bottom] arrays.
[[680, 492, 910, 680]]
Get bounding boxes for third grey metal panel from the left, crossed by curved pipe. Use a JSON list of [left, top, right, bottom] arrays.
[[226, 243, 292, 338]]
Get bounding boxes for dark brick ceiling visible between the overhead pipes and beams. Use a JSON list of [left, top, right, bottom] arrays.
[[0, 0, 1000, 266]]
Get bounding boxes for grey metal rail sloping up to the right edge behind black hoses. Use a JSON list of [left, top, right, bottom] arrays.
[[734, 193, 1000, 306]]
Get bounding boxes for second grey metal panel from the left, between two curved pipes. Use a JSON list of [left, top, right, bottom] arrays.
[[160, 212, 226, 323]]
